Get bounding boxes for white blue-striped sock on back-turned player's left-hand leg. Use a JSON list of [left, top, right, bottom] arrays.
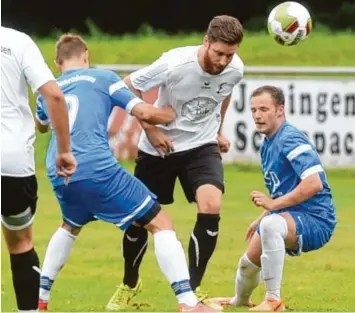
[[39, 227, 76, 302]]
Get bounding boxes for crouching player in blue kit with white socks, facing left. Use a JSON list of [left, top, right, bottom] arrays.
[[211, 86, 337, 312]]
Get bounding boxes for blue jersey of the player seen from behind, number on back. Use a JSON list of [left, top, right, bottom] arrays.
[[36, 68, 142, 186]]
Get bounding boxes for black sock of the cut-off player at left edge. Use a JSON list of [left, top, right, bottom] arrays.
[[10, 248, 40, 311]]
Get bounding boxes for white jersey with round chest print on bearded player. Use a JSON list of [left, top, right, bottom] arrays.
[[131, 46, 244, 155]]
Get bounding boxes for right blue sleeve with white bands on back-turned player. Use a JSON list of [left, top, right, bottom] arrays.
[[106, 72, 143, 114]]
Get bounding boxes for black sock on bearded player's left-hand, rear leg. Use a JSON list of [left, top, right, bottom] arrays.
[[123, 225, 148, 288]]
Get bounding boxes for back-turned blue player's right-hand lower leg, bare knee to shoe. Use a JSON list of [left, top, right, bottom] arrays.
[[145, 211, 219, 312]]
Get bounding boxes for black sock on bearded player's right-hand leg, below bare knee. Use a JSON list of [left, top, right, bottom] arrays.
[[189, 213, 220, 290]]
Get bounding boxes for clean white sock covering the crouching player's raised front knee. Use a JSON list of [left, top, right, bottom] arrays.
[[260, 214, 288, 300]]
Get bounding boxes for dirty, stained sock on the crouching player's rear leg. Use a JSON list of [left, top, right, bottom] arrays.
[[231, 253, 260, 306]]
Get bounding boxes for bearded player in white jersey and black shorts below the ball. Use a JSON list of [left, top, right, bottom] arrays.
[[107, 15, 244, 310]]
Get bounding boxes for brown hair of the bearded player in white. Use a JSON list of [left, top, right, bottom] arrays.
[[206, 15, 243, 45]]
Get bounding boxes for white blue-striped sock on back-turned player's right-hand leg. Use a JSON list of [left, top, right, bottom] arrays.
[[154, 230, 198, 306]]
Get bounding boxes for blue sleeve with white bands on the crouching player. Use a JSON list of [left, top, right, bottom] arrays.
[[282, 134, 324, 179]]
